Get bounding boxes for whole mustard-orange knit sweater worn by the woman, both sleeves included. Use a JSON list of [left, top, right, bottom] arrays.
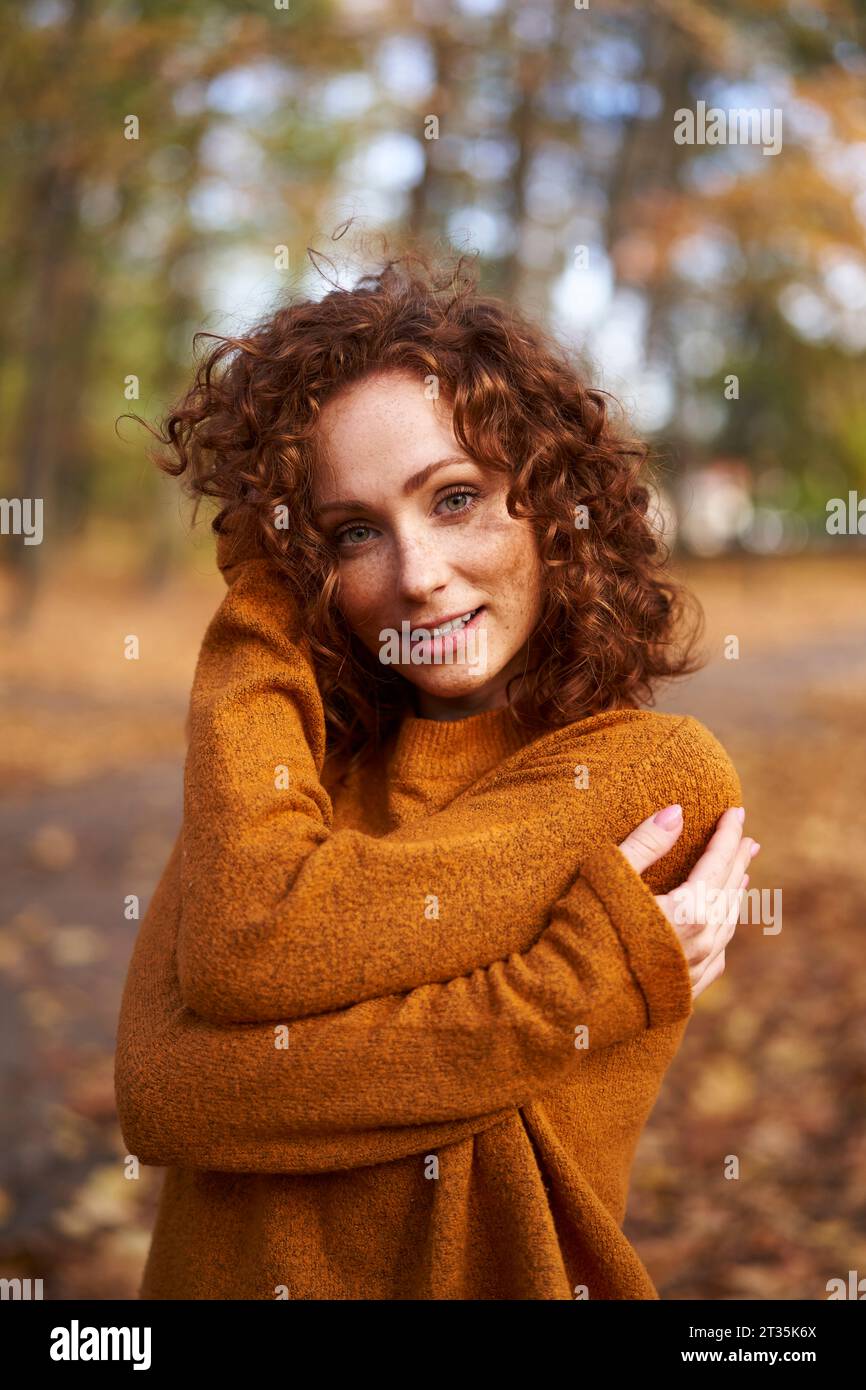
[[115, 547, 741, 1300]]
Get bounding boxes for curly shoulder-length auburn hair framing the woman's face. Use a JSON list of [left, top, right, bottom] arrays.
[[127, 236, 703, 783]]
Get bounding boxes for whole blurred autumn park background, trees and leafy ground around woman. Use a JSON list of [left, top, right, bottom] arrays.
[[0, 0, 866, 1300]]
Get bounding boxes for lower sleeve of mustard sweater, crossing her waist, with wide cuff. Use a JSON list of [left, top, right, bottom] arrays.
[[115, 828, 692, 1173]]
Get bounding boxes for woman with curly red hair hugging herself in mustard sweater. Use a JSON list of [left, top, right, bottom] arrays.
[[117, 244, 753, 1300]]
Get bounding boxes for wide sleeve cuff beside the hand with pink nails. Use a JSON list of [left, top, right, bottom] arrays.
[[580, 844, 694, 1027]]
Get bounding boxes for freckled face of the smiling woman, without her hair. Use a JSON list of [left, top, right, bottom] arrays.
[[313, 373, 542, 719]]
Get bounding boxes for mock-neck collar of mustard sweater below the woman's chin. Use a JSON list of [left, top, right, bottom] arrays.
[[389, 705, 535, 783]]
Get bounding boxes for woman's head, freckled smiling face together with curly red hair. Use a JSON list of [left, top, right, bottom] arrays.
[[140, 241, 701, 783]]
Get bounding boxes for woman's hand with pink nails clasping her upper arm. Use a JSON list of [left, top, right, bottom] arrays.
[[619, 806, 760, 999]]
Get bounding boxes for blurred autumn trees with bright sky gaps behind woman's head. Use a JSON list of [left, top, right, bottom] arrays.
[[0, 0, 866, 603]]
